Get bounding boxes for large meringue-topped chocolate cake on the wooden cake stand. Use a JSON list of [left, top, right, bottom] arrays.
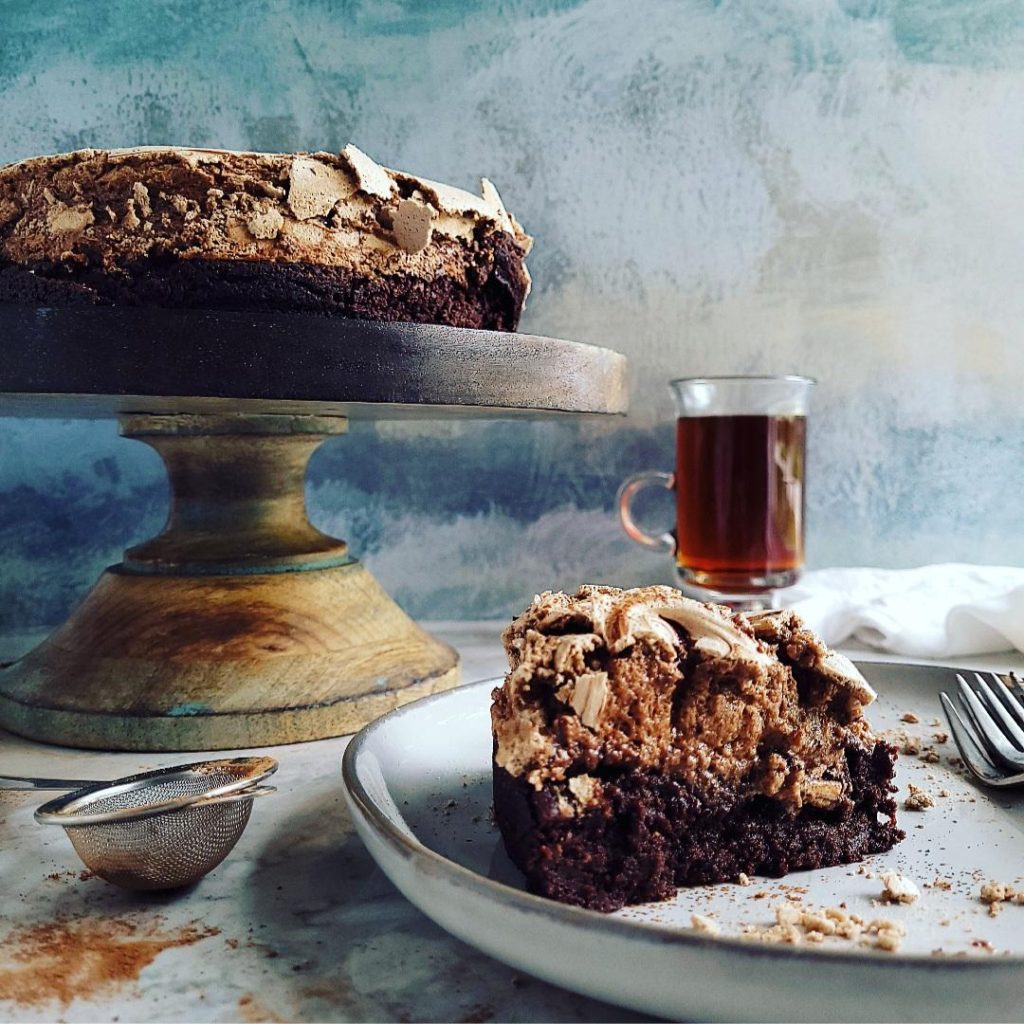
[[0, 145, 530, 331]]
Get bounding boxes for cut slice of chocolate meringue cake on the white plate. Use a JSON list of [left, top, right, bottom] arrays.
[[492, 587, 903, 910]]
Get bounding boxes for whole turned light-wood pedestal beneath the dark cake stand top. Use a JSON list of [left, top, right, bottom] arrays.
[[0, 416, 459, 751]]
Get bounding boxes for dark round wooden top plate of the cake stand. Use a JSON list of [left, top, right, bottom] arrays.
[[0, 305, 628, 419]]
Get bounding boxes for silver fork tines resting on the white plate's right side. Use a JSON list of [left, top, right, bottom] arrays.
[[940, 672, 1024, 785]]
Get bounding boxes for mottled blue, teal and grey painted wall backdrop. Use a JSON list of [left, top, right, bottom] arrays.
[[0, 0, 1024, 632]]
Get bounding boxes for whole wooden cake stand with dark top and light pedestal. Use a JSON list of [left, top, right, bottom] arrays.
[[0, 306, 627, 751]]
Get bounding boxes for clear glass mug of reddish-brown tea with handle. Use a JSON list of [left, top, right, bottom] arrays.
[[618, 377, 815, 608]]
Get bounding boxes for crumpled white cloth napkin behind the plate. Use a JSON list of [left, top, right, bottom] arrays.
[[776, 563, 1024, 658]]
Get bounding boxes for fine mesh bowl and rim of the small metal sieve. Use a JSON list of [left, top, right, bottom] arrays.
[[36, 758, 278, 889]]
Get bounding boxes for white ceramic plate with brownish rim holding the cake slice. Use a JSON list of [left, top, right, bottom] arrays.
[[343, 664, 1024, 1021]]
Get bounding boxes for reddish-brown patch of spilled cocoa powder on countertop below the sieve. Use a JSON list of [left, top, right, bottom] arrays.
[[0, 916, 220, 1007]]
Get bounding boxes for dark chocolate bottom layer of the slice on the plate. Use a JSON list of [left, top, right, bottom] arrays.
[[494, 742, 903, 911]]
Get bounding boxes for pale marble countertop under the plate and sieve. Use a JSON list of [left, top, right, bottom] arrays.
[[6, 624, 1024, 1021]]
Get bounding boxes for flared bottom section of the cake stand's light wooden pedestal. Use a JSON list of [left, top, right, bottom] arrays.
[[0, 563, 459, 751]]
